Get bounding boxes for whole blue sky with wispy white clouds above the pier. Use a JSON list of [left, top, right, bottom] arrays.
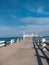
[[0, 0, 49, 37]]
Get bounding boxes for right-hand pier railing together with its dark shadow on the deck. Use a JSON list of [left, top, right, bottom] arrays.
[[32, 37, 49, 65]]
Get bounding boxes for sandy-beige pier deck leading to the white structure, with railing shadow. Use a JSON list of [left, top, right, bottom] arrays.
[[0, 38, 49, 65]]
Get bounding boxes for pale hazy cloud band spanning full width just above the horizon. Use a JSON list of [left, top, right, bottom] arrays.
[[0, 25, 49, 36]]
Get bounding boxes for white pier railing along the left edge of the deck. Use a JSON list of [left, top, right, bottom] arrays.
[[0, 38, 23, 47]]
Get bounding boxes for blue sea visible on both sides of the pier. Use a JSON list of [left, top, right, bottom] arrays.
[[0, 36, 49, 44]]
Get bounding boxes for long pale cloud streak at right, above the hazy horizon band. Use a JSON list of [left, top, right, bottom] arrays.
[[20, 17, 49, 25]]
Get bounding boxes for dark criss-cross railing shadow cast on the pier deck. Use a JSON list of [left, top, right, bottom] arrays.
[[33, 39, 49, 65]]
